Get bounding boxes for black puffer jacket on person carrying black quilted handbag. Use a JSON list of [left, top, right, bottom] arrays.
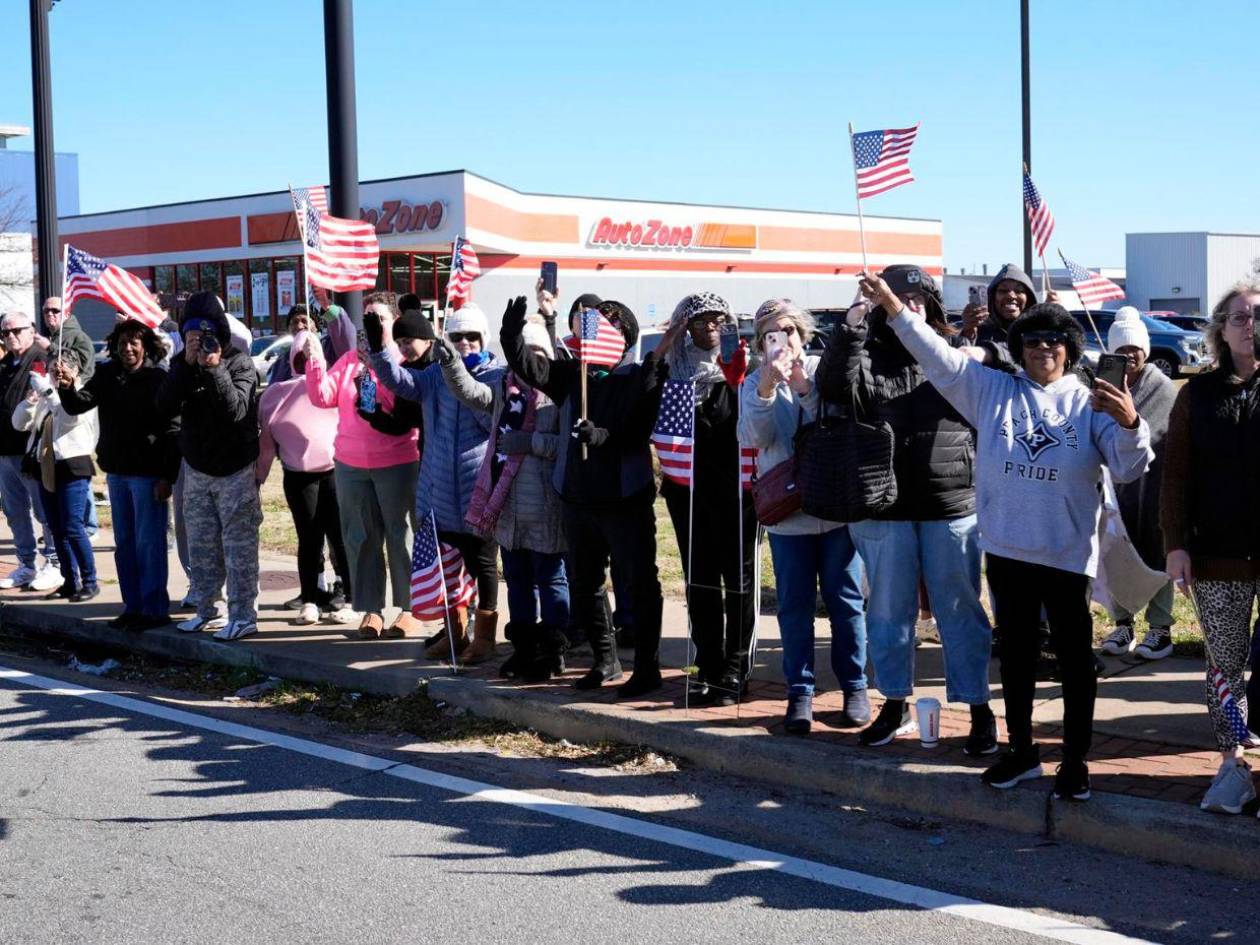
[[814, 312, 975, 522]]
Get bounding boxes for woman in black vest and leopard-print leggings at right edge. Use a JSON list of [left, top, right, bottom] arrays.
[[1159, 280, 1260, 814]]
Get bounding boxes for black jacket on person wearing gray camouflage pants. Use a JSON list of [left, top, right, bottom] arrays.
[[158, 347, 258, 476]]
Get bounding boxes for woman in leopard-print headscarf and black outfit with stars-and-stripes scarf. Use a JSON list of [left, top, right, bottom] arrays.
[[653, 292, 759, 706]]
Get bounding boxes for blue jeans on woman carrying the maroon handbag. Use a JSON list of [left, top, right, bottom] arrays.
[[770, 527, 867, 696]]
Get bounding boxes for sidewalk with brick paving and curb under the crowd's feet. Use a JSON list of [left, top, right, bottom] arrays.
[[0, 522, 1260, 877]]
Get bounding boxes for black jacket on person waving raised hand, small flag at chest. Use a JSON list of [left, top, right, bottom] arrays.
[[499, 307, 669, 505]]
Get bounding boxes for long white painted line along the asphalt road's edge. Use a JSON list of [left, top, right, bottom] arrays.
[[0, 667, 1152, 945]]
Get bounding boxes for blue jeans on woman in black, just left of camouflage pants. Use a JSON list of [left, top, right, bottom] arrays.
[[106, 473, 170, 617]]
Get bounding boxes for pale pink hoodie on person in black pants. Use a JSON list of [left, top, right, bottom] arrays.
[[255, 331, 336, 483]]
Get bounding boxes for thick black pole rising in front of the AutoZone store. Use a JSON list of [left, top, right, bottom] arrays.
[[324, 0, 363, 326]]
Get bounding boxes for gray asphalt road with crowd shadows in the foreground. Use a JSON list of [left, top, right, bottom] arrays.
[[0, 656, 1260, 945]]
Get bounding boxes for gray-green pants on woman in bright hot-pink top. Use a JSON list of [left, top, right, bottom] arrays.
[[334, 461, 420, 614]]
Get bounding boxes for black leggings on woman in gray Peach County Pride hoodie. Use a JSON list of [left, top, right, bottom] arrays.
[[985, 554, 1097, 761]]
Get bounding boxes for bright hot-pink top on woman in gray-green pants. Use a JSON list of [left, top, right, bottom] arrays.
[[303, 341, 420, 469]]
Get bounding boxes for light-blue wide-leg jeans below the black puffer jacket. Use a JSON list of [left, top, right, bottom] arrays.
[[849, 515, 993, 706]]
